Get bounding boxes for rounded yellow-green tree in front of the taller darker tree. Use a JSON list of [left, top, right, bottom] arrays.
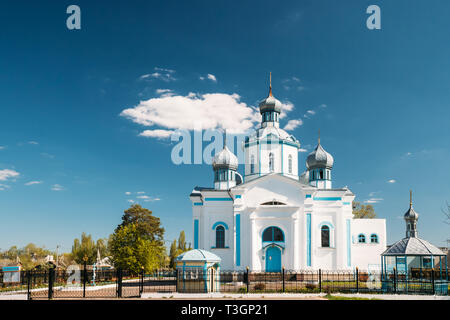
[[110, 223, 165, 273]]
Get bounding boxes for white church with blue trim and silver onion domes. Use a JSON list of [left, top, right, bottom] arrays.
[[190, 77, 386, 272]]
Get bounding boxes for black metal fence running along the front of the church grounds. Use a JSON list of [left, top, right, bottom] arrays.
[[0, 268, 449, 299]]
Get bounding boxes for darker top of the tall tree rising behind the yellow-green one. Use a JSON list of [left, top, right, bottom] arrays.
[[116, 204, 164, 242]]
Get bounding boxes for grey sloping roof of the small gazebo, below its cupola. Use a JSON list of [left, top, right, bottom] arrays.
[[381, 237, 445, 256]]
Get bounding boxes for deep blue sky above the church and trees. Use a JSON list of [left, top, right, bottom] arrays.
[[0, 0, 450, 251]]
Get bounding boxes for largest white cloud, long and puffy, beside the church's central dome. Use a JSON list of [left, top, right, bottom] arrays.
[[120, 93, 268, 137]]
